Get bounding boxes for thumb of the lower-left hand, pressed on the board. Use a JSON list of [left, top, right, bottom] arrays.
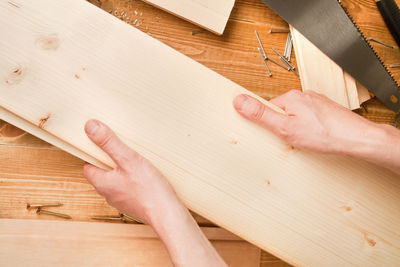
[[85, 120, 139, 169]]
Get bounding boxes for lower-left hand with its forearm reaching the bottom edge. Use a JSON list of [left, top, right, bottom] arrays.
[[83, 120, 226, 266]]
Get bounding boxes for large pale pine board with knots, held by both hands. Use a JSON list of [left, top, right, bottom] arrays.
[[0, 0, 400, 266]]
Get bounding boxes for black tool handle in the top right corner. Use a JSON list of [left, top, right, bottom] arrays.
[[376, 0, 400, 47]]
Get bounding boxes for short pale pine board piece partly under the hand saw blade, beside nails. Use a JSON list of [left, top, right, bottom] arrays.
[[291, 27, 369, 110]]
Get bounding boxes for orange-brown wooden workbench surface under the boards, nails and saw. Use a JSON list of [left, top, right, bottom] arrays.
[[0, 0, 400, 266]]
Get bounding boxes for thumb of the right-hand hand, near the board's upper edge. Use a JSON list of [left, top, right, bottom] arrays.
[[233, 95, 287, 132]]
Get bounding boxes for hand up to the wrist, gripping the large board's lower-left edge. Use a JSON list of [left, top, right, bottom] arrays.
[[83, 120, 182, 225]]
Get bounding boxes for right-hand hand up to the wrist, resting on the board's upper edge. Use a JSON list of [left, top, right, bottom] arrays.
[[233, 90, 385, 155]]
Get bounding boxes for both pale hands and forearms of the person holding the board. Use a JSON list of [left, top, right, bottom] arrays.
[[83, 91, 400, 266]]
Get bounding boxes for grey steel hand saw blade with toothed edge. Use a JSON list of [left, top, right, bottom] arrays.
[[262, 0, 400, 112]]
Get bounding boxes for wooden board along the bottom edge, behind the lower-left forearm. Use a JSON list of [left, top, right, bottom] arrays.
[[0, 219, 260, 267]]
